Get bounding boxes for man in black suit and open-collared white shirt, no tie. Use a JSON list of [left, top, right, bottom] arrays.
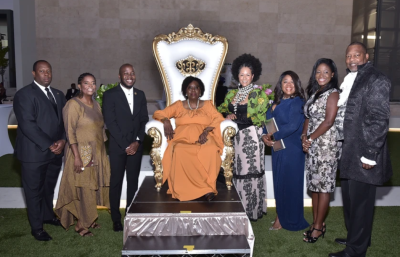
[[103, 64, 149, 231]]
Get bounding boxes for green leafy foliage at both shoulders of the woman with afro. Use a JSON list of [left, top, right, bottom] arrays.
[[217, 84, 274, 127]]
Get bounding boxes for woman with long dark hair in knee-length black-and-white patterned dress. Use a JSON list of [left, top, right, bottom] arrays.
[[301, 58, 341, 243]]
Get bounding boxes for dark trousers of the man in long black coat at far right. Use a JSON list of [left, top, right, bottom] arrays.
[[341, 179, 376, 257]]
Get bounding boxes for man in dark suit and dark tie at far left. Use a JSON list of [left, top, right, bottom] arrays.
[[14, 60, 65, 241]]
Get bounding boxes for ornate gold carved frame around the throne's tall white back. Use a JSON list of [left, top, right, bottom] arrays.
[[153, 24, 228, 106]]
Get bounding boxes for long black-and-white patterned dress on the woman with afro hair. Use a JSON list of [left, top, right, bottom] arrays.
[[229, 104, 267, 221]]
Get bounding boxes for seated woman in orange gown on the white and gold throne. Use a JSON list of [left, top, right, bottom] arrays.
[[153, 76, 224, 201]]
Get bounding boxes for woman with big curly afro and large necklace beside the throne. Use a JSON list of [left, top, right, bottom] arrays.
[[218, 54, 268, 221]]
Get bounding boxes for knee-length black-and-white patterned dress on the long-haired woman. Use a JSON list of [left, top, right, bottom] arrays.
[[304, 89, 341, 193]]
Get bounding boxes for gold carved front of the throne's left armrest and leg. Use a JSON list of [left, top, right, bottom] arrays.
[[147, 127, 163, 192]]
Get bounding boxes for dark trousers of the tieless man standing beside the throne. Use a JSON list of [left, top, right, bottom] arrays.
[[110, 151, 142, 222]]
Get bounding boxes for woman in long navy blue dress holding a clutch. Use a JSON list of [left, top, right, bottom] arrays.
[[263, 71, 309, 231]]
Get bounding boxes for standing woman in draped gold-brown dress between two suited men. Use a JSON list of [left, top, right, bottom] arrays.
[[55, 73, 110, 236]]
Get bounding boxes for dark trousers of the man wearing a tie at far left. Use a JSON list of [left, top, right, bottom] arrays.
[[21, 158, 62, 231]]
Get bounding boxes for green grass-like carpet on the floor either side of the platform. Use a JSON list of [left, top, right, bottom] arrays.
[[0, 207, 400, 257]]
